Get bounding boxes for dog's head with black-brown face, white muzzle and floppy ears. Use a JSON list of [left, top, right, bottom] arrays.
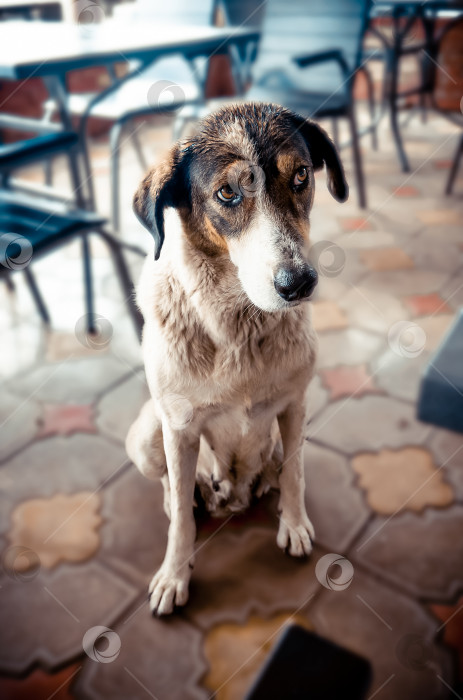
[[134, 104, 348, 311]]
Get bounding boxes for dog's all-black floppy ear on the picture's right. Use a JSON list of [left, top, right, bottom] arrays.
[[294, 115, 349, 202]]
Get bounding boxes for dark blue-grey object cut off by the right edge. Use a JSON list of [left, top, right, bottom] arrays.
[[418, 310, 463, 433]]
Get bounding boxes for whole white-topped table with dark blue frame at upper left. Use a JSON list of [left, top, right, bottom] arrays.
[[0, 20, 259, 208]]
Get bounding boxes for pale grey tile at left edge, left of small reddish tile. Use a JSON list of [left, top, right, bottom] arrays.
[[0, 387, 41, 460]]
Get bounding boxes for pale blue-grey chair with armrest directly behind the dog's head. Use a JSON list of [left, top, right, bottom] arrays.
[[246, 0, 369, 208]]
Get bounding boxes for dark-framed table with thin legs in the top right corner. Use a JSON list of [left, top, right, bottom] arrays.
[[370, 0, 463, 172]]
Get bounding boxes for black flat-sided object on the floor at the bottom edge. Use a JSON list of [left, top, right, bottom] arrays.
[[245, 625, 371, 700]]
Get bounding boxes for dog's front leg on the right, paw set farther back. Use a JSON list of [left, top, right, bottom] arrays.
[[277, 399, 314, 557]]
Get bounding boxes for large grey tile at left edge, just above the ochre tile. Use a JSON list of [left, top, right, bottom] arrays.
[[0, 434, 128, 532]]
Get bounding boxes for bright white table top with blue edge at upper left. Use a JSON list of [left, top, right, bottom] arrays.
[[0, 20, 259, 80]]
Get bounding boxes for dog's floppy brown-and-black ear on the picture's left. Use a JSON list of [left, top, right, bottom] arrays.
[[133, 144, 190, 260]]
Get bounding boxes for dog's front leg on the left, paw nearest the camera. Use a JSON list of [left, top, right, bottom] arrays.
[[149, 419, 199, 615]]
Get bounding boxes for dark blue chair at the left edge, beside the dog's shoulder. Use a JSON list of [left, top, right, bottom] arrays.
[[0, 132, 143, 336]]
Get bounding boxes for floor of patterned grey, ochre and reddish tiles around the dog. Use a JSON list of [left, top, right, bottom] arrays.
[[0, 105, 463, 700]]
